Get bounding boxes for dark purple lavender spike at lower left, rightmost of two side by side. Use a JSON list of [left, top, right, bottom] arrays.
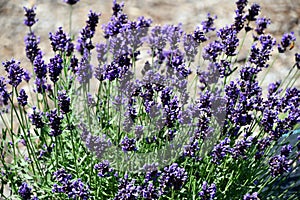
[[46, 109, 63, 137]]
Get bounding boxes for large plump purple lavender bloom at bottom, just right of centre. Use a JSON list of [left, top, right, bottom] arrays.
[[159, 163, 187, 193]]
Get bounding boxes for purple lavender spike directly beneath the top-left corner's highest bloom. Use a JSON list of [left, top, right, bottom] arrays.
[[24, 32, 40, 63]]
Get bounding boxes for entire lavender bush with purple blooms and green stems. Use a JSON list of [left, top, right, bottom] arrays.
[[0, 0, 300, 200]]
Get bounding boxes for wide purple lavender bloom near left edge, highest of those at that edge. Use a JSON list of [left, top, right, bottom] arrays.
[[2, 59, 24, 88]]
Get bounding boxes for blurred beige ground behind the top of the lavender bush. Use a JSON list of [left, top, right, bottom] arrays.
[[0, 0, 300, 85]]
